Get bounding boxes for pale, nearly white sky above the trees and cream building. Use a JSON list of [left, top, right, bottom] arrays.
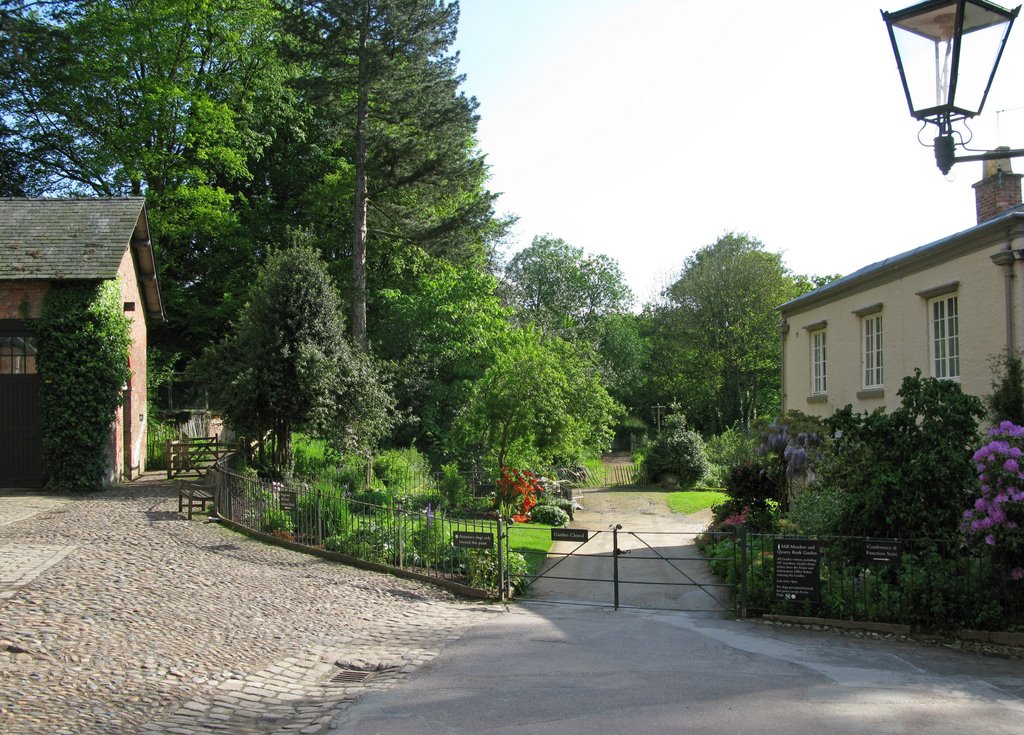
[[456, 0, 1024, 303]]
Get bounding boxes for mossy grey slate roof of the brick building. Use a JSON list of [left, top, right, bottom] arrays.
[[0, 197, 164, 319]]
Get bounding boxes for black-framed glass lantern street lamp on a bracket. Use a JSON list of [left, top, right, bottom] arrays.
[[882, 0, 1024, 174]]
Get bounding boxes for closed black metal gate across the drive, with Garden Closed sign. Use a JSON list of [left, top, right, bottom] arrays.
[[505, 524, 735, 613]]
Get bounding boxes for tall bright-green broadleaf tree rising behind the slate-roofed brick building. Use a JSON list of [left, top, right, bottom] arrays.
[[0, 0, 288, 354]]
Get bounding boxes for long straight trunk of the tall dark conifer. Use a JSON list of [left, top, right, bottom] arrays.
[[352, 0, 370, 351]]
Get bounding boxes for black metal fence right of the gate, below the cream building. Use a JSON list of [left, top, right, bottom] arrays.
[[705, 532, 1024, 630]]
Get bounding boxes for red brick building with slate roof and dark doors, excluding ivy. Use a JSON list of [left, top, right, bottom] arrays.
[[0, 198, 164, 487]]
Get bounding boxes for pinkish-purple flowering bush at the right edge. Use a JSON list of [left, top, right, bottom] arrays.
[[961, 421, 1024, 580]]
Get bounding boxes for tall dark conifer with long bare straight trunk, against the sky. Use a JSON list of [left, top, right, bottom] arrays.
[[292, 0, 494, 346]]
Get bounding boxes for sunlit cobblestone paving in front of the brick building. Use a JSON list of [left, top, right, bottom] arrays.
[[0, 478, 493, 735]]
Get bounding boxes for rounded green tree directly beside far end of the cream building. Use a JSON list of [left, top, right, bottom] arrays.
[[652, 232, 810, 433]]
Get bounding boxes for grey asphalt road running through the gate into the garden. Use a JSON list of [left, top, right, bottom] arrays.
[[330, 491, 1024, 735]]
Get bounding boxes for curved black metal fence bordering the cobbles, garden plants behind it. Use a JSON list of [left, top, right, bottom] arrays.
[[210, 458, 503, 594]]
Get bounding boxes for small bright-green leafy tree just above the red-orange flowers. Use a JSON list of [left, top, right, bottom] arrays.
[[457, 329, 620, 469]]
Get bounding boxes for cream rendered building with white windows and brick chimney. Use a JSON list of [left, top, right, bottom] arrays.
[[779, 160, 1024, 416]]
